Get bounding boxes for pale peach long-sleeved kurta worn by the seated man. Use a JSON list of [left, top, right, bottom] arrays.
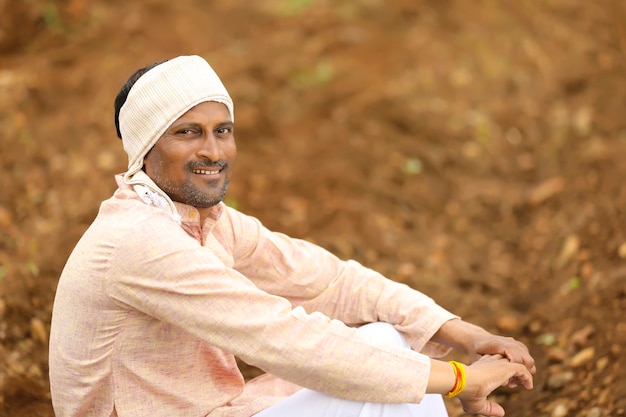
[[50, 176, 455, 417]]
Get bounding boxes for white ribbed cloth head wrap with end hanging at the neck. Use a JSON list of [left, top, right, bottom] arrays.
[[119, 55, 234, 223]]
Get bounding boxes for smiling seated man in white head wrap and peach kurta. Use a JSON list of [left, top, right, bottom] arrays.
[[50, 56, 535, 417]]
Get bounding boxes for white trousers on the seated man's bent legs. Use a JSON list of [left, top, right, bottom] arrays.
[[255, 323, 448, 417]]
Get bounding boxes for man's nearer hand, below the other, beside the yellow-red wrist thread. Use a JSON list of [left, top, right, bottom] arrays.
[[458, 355, 533, 417]]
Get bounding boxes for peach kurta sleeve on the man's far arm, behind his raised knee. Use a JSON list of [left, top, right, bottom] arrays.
[[218, 209, 457, 357]]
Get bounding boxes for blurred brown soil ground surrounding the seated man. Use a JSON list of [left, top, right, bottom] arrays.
[[0, 0, 626, 417]]
